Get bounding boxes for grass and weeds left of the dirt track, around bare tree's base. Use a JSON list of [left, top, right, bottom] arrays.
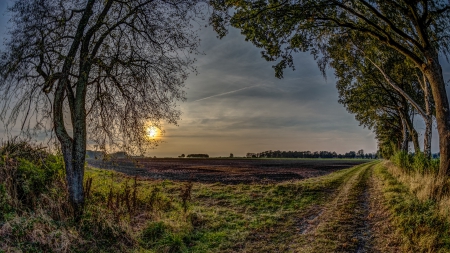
[[0, 139, 376, 252]]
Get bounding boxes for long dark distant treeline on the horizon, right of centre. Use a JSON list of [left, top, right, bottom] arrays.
[[247, 149, 377, 159]]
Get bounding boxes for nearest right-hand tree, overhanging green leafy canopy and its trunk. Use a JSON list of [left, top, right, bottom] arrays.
[[210, 0, 450, 182]]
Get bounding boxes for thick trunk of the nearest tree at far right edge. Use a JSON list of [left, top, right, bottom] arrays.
[[423, 52, 450, 180]]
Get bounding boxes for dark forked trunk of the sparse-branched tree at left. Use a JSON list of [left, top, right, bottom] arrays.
[[53, 0, 95, 217]]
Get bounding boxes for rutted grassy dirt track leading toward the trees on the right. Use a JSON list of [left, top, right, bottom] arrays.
[[286, 163, 399, 253]]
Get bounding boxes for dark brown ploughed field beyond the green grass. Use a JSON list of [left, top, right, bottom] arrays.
[[87, 158, 369, 184]]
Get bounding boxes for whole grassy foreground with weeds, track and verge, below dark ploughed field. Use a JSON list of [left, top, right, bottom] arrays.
[[0, 143, 450, 252]]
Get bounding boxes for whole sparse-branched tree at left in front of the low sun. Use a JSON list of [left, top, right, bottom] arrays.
[[0, 0, 200, 216]]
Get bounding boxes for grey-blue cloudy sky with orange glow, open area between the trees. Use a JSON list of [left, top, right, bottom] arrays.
[[0, 0, 448, 157]]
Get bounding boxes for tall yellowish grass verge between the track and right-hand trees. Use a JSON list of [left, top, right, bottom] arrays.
[[375, 162, 450, 252]]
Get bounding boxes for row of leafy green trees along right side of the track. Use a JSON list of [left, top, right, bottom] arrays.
[[210, 0, 450, 196]]
